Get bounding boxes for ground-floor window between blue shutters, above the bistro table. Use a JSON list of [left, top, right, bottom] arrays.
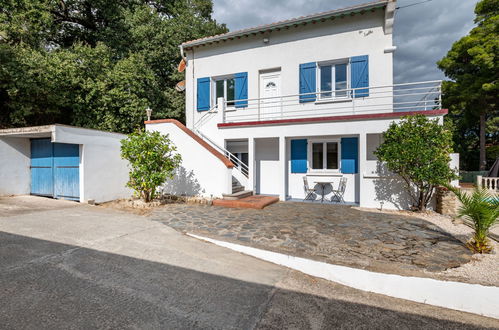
[[309, 141, 340, 171]]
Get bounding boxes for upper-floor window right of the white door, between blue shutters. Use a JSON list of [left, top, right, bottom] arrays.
[[318, 61, 350, 99]]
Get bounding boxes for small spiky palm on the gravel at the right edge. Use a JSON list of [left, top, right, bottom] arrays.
[[449, 187, 499, 253]]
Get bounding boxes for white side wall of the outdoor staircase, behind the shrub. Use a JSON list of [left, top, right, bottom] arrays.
[[146, 123, 232, 198]]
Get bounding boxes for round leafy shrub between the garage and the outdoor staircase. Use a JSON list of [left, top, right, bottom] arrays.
[[121, 131, 182, 202]]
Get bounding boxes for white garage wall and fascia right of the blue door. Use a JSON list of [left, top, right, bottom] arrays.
[[52, 125, 133, 203]]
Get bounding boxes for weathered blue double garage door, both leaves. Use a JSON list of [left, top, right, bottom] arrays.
[[31, 139, 80, 200]]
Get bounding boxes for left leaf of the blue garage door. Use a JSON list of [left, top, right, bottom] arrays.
[[31, 139, 54, 196]]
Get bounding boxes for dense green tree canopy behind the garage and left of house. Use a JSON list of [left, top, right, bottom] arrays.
[[0, 0, 227, 133]]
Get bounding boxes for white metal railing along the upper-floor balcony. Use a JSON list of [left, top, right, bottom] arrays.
[[216, 80, 442, 127]]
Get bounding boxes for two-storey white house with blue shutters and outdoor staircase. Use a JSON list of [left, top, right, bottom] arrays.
[[146, 0, 454, 208]]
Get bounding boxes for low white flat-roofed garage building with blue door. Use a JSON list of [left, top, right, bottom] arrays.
[[0, 124, 132, 203]]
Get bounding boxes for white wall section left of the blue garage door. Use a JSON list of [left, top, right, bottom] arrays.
[[0, 137, 31, 196]]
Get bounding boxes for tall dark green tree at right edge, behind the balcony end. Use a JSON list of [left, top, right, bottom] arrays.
[[437, 0, 499, 170]]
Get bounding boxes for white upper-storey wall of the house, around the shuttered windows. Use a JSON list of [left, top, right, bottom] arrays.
[[186, 10, 393, 130]]
